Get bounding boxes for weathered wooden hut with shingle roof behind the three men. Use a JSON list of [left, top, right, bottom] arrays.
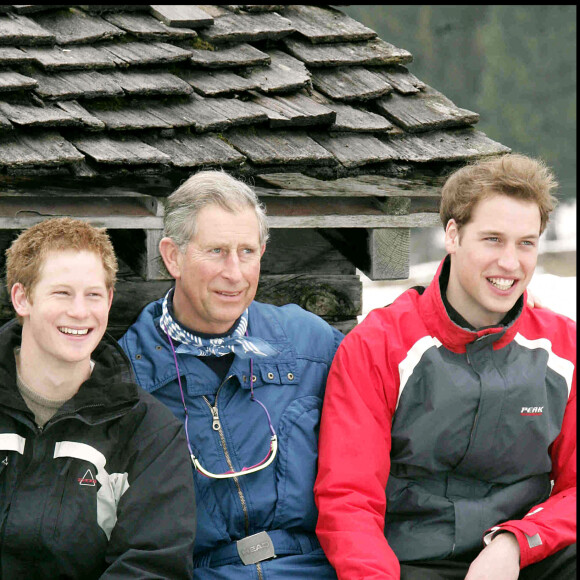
[[0, 5, 509, 337]]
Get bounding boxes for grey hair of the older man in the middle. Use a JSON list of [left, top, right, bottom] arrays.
[[163, 171, 268, 252]]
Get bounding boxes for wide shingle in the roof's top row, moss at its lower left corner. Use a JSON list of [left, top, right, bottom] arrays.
[[199, 12, 294, 44]]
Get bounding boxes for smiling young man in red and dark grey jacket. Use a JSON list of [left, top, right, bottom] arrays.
[[315, 155, 576, 580]]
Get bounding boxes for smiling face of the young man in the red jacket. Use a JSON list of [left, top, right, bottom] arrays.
[[445, 194, 540, 328]]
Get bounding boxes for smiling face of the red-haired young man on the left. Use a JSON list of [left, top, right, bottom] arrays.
[[11, 250, 113, 368]]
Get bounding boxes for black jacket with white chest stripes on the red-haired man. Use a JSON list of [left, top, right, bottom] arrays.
[[0, 320, 196, 580]]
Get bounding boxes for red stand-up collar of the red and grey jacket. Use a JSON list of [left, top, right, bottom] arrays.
[[420, 255, 527, 352]]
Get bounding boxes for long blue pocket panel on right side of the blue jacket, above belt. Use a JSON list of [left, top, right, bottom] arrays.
[[272, 396, 322, 530]]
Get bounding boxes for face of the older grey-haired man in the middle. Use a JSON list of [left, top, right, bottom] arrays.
[[159, 205, 265, 334]]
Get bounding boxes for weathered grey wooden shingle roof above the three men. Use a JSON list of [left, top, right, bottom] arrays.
[[0, 5, 505, 177]]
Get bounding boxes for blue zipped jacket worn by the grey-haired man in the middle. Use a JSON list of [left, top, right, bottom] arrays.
[[121, 300, 342, 580]]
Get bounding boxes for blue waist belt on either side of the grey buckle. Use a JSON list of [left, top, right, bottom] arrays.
[[193, 530, 320, 568]]
